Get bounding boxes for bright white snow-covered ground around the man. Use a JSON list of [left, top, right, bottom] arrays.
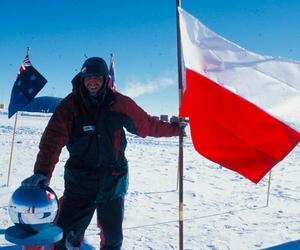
[[0, 113, 300, 250]]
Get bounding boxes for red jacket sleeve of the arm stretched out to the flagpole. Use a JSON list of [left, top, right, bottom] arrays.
[[118, 96, 180, 137]]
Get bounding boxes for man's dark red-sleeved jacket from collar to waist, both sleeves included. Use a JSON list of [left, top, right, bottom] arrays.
[[34, 79, 180, 186]]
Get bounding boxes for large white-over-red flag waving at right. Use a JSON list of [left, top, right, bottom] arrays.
[[178, 8, 300, 183]]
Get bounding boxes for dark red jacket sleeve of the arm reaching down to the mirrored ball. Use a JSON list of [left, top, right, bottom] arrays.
[[34, 96, 73, 179]]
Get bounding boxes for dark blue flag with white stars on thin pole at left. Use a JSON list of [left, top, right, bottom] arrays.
[[8, 54, 47, 118]]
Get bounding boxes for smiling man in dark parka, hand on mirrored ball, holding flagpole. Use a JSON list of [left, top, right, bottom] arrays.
[[22, 57, 181, 250]]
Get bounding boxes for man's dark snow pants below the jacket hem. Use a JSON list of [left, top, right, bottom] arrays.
[[54, 196, 124, 250]]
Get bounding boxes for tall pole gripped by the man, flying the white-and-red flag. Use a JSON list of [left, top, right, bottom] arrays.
[[176, 0, 183, 250]]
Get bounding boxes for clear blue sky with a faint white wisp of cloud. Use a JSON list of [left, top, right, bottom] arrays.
[[0, 0, 300, 114]]
